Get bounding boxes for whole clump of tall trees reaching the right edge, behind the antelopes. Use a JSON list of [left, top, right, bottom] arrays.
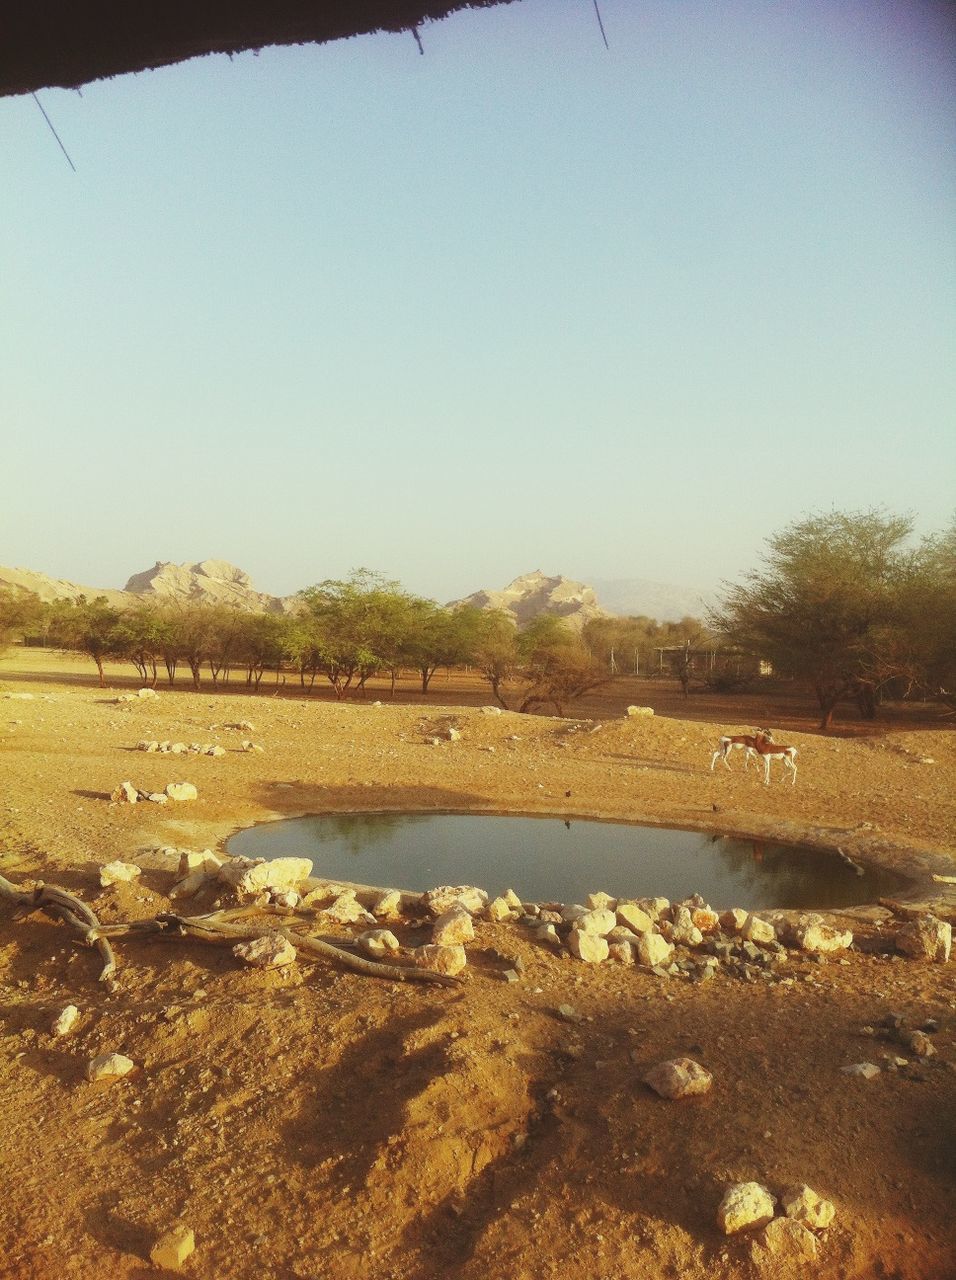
[[709, 509, 956, 730]]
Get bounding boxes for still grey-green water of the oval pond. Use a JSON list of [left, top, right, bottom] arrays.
[[227, 813, 905, 910]]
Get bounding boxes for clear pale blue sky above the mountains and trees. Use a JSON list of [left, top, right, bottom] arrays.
[[0, 0, 956, 600]]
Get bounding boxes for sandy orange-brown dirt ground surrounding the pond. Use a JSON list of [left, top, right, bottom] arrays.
[[0, 652, 956, 1280]]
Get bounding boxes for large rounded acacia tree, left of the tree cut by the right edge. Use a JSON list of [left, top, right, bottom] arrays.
[[710, 511, 915, 730]]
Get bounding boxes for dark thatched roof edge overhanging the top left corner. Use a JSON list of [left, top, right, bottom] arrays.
[[0, 0, 524, 96]]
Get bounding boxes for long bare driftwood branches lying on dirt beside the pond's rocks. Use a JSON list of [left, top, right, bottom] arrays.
[[0, 876, 461, 987]]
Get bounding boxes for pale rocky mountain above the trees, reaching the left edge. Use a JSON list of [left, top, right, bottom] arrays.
[[0, 559, 291, 612]]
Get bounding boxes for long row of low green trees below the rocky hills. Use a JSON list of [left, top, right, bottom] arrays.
[[0, 570, 608, 716]]
